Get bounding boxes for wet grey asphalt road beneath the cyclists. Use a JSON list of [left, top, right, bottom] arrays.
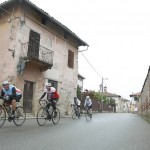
[[0, 113, 150, 150]]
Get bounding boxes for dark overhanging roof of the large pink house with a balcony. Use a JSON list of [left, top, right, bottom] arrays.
[[0, 0, 89, 46]]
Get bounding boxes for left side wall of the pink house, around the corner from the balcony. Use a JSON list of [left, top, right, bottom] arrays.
[[0, 10, 15, 82]]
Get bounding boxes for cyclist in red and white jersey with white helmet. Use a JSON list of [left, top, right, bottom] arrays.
[[40, 83, 59, 113]]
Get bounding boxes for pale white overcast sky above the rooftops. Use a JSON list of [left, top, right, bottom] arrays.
[[0, 0, 150, 99]]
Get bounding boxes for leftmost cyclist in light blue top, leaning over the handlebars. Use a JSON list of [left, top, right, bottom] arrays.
[[1, 81, 22, 118]]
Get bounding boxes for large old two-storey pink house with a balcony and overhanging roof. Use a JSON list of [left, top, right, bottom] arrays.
[[0, 0, 88, 115]]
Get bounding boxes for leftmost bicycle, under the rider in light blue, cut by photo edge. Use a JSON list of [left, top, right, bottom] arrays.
[[0, 96, 26, 127]]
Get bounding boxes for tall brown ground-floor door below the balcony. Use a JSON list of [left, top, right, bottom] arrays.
[[23, 81, 34, 113]]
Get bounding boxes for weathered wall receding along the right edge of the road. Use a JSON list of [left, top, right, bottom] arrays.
[[138, 67, 150, 121]]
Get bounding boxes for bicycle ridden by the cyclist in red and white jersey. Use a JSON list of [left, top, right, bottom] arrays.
[[37, 100, 60, 126]]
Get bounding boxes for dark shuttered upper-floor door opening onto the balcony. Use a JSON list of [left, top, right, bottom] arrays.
[[28, 30, 40, 59]]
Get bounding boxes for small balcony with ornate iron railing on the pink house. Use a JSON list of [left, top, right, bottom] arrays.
[[21, 43, 54, 71]]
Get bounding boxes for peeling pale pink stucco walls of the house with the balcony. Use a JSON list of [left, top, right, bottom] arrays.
[[0, 3, 78, 116]]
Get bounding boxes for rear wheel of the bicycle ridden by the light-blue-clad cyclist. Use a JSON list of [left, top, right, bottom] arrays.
[[13, 106, 26, 126]]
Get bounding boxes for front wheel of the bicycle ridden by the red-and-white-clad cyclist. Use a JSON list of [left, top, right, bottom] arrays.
[[36, 107, 47, 126]]
